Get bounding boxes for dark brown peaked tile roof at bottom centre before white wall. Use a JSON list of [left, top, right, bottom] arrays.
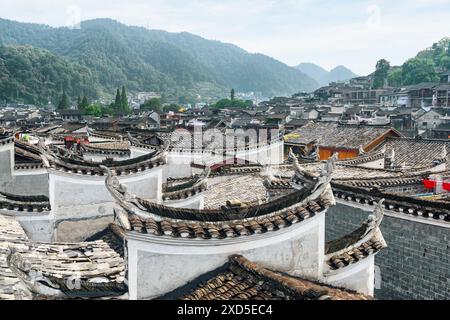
[[173, 255, 372, 300]]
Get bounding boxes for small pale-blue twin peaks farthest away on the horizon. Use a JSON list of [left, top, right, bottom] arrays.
[[296, 63, 357, 86]]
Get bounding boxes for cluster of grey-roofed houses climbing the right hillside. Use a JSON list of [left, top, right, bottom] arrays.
[[260, 71, 450, 139]]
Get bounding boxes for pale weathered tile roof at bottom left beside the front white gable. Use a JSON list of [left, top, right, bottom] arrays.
[[8, 241, 127, 299]]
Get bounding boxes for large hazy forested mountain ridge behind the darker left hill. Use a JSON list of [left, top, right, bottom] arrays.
[[0, 19, 318, 104]]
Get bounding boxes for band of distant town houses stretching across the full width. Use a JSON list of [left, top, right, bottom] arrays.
[[0, 71, 450, 139]]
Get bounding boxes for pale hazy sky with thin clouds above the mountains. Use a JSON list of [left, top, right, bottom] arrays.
[[0, 0, 450, 74]]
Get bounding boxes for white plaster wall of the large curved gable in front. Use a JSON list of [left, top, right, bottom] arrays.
[[127, 213, 325, 299]]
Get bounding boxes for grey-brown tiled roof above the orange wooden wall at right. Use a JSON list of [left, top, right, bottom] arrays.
[[285, 122, 400, 149]]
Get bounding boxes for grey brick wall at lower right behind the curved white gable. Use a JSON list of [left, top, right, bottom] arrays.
[[326, 203, 450, 300]]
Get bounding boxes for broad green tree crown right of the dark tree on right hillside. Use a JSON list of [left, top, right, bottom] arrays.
[[402, 58, 439, 85]]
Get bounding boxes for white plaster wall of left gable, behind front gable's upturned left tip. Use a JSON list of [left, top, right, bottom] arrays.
[[21, 167, 162, 242]]
